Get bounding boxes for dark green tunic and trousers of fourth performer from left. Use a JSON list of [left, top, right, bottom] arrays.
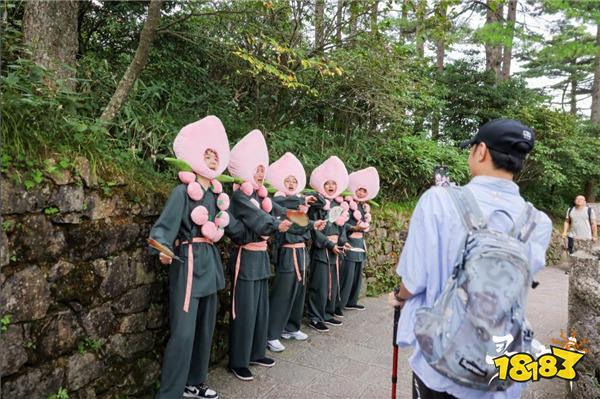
[[308, 195, 347, 322]]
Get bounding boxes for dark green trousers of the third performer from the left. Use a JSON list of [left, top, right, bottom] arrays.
[[268, 272, 306, 341]]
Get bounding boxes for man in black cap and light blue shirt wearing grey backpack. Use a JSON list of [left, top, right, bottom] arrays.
[[390, 119, 552, 399]]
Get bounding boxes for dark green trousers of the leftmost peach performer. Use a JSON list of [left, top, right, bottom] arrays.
[[157, 290, 218, 399]]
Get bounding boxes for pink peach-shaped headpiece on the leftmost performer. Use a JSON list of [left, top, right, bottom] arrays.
[[173, 115, 230, 179]]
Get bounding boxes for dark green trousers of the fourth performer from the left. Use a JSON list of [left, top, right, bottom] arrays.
[[308, 255, 338, 322]]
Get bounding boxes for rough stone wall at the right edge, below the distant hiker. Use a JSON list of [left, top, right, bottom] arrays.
[[568, 240, 600, 399]]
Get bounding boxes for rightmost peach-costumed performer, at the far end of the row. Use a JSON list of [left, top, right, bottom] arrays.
[[336, 167, 379, 317]]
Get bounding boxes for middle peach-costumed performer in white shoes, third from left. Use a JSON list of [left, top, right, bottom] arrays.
[[267, 152, 325, 352]]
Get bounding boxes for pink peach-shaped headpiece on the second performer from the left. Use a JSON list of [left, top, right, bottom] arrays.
[[227, 130, 269, 189]]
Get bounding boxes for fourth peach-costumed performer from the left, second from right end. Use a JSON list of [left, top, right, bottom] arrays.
[[308, 156, 348, 332]]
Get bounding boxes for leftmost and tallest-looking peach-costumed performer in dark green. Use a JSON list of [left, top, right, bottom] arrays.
[[150, 116, 244, 399]]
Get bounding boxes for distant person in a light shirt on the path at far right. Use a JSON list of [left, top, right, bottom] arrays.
[[562, 195, 598, 254]]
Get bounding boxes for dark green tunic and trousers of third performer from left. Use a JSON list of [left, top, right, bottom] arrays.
[[268, 195, 312, 340]]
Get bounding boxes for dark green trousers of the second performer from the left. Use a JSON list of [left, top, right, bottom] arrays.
[[229, 279, 269, 368]]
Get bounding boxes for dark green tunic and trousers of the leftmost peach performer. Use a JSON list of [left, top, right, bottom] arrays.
[[150, 184, 244, 399]]
